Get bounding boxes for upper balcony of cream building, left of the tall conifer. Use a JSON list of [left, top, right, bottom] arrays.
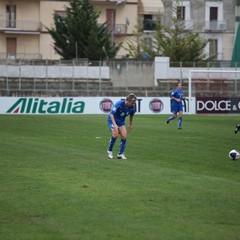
[[0, 19, 42, 34]]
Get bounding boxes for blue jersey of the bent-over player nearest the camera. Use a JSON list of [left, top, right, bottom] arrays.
[[108, 100, 136, 127]]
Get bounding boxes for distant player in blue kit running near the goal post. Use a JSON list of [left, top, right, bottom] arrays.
[[167, 83, 184, 129]]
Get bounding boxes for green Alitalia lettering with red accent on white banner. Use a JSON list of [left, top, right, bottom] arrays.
[[7, 98, 85, 114]]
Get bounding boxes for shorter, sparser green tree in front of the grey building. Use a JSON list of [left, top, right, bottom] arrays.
[[125, 16, 213, 63]]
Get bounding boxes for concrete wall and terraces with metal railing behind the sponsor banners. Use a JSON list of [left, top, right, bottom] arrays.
[[0, 59, 240, 96]]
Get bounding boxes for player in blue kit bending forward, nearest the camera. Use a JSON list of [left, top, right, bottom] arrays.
[[107, 93, 137, 159]]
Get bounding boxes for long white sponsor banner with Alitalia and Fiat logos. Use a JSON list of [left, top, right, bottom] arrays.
[[0, 97, 195, 114]]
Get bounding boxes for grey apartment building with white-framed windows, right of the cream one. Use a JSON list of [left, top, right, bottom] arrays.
[[162, 0, 236, 61]]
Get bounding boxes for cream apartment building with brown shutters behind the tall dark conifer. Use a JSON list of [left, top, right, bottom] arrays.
[[0, 0, 138, 59]]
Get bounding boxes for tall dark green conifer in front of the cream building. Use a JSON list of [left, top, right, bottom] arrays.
[[47, 0, 121, 60]]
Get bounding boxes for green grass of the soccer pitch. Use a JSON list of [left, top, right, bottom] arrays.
[[0, 115, 240, 240]]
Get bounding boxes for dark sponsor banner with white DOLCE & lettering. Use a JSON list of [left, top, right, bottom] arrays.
[[196, 98, 240, 113]]
